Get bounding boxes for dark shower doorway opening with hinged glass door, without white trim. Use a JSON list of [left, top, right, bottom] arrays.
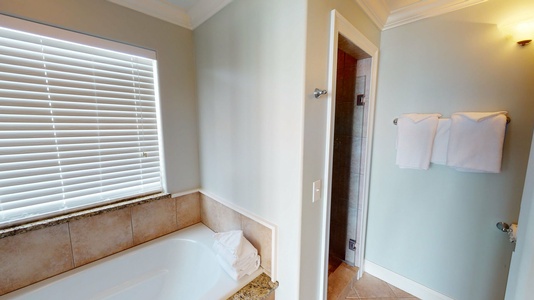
[[329, 35, 372, 270]]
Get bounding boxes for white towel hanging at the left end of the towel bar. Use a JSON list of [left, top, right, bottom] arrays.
[[396, 114, 441, 170]]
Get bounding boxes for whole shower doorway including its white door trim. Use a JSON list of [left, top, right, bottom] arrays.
[[322, 10, 378, 299]]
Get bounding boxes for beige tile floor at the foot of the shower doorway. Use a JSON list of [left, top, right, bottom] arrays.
[[328, 256, 418, 300]]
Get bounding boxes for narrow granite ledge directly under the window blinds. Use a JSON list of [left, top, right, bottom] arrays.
[[0, 193, 171, 239]]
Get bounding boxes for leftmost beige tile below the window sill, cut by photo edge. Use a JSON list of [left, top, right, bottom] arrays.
[[0, 224, 74, 295]]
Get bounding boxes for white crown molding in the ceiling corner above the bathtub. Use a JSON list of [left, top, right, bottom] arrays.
[[107, 0, 232, 30]]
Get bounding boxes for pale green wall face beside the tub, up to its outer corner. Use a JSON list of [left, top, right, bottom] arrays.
[[194, 0, 306, 299]]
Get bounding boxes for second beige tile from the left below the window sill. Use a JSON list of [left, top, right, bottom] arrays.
[[69, 208, 133, 267]]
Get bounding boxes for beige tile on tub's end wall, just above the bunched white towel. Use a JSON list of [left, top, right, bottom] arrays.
[[200, 194, 241, 232]]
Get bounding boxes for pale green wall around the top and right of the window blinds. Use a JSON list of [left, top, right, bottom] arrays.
[[0, 0, 200, 193]]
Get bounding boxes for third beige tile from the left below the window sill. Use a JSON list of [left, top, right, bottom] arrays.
[[132, 198, 177, 245]]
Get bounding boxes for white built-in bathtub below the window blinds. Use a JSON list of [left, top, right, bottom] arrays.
[[0, 223, 262, 300]]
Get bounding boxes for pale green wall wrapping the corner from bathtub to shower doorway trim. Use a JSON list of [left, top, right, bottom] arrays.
[[194, 0, 380, 299]]
